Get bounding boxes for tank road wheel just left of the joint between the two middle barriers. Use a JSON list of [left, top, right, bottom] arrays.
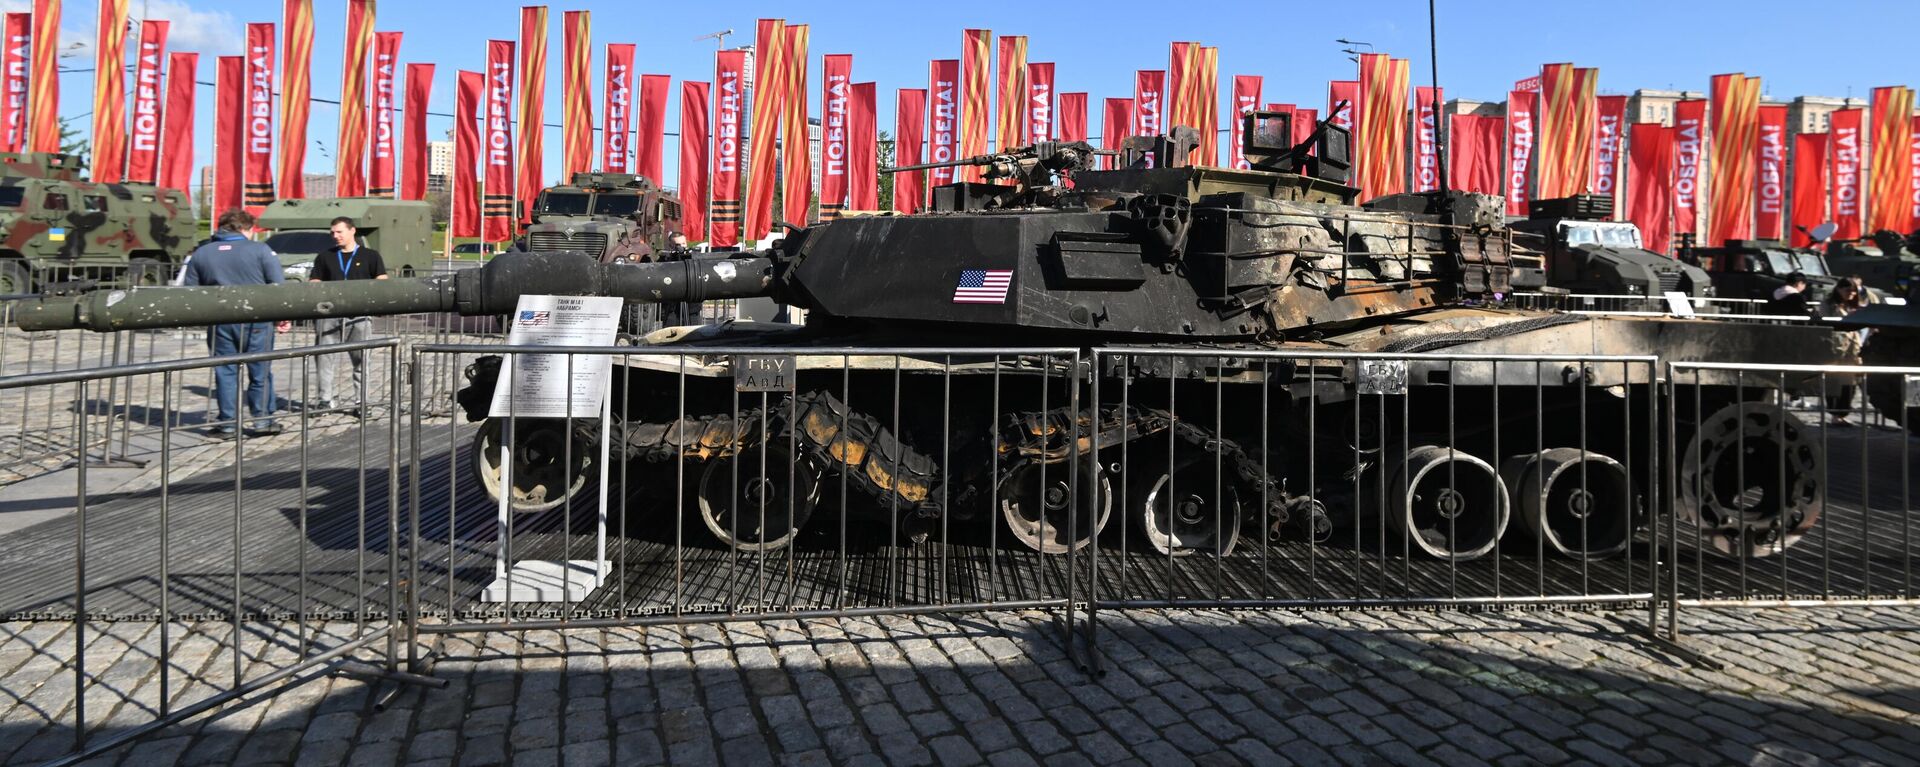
[[996, 459, 1114, 554]]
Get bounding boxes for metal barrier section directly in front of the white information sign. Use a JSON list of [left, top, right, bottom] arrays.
[[407, 344, 1081, 665]]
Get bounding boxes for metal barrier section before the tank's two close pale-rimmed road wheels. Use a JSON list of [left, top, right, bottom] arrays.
[[1085, 348, 1661, 661]]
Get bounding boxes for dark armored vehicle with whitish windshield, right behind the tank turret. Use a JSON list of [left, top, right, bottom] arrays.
[[1511, 194, 1715, 300]]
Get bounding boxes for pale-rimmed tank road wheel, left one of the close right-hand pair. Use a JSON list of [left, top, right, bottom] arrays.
[[1384, 444, 1507, 561]]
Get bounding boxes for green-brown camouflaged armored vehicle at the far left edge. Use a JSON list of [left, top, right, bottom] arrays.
[[0, 152, 194, 294]]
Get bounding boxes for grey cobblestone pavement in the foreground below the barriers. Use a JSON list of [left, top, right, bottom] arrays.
[[0, 607, 1920, 767]]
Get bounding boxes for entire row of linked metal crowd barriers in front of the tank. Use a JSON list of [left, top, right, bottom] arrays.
[[0, 338, 1920, 757]]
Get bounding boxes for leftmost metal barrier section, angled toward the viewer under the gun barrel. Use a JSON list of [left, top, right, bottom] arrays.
[[0, 340, 435, 761]]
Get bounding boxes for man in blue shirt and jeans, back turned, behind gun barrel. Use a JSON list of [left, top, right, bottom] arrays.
[[180, 208, 286, 438]]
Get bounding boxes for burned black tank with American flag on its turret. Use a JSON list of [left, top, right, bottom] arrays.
[[15, 111, 1839, 561]]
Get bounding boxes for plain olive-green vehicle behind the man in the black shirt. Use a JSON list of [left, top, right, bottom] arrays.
[[259, 198, 434, 279]]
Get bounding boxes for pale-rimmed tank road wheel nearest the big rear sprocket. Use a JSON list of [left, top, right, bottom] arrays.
[[1500, 448, 1634, 559]]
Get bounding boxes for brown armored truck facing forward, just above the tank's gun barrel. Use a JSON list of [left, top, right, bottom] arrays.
[[516, 173, 680, 263]]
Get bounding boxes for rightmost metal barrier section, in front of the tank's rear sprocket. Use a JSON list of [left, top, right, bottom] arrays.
[[1665, 361, 1920, 632]]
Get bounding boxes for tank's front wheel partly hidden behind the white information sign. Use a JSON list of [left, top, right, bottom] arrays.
[[472, 419, 593, 511]]
